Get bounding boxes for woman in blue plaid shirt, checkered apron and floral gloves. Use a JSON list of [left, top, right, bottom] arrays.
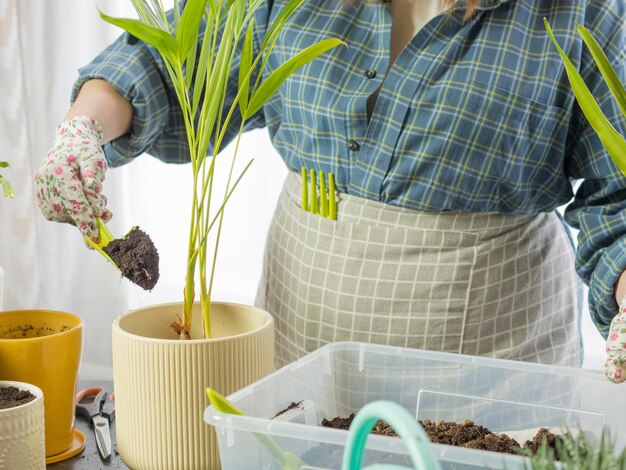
[[36, 0, 626, 376]]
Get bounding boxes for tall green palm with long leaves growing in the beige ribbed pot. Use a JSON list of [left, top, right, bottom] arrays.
[[100, 0, 343, 339]]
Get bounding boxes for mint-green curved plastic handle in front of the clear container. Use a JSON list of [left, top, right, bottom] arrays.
[[341, 400, 441, 470]]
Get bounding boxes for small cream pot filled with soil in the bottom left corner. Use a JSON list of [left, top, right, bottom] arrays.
[[0, 380, 46, 470]]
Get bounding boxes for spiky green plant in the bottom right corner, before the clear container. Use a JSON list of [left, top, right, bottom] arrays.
[[522, 428, 626, 470]]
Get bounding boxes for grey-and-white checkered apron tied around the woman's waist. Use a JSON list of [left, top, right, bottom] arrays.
[[256, 172, 581, 366]]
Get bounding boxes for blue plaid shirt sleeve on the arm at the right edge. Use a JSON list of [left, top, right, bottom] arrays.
[[565, 2, 626, 337]]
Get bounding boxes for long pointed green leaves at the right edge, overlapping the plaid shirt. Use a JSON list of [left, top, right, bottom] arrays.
[[543, 18, 626, 175]]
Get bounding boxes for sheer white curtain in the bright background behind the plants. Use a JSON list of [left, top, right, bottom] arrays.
[[0, 0, 286, 379]]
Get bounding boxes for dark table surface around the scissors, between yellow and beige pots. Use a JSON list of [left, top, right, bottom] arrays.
[[46, 381, 128, 470]]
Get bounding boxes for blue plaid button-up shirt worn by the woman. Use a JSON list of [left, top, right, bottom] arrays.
[[74, 0, 626, 334]]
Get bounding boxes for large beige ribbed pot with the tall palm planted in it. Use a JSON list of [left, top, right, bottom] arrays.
[[113, 302, 274, 470]]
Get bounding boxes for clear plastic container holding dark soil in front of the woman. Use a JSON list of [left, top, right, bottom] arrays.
[[204, 342, 626, 470]]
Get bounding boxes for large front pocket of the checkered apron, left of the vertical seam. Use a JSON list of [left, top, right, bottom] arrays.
[[263, 193, 477, 365]]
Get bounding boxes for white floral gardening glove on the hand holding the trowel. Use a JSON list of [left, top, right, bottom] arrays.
[[35, 116, 112, 243]]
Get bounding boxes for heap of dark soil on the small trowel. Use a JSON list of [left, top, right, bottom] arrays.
[[103, 227, 159, 290]]
